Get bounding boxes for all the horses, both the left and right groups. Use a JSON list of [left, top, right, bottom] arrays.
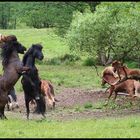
[[0, 35, 140, 119]]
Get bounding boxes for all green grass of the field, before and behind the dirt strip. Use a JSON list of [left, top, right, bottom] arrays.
[[0, 29, 140, 138]]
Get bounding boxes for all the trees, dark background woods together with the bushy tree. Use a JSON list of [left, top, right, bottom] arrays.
[[0, 2, 140, 65]]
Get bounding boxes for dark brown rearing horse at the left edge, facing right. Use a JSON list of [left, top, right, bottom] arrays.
[[0, 35, 29, 119]]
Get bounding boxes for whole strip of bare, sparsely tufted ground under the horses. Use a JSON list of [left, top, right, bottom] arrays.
[[5, 87, 140, 121]]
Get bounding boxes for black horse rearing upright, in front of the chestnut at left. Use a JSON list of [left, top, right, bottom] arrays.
[[21, 44, 46, 119]]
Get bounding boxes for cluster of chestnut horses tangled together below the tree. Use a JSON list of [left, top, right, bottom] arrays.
[[102, 60, 140, 103]]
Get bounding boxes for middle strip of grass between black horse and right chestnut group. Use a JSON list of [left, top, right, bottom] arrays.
[[13, 65, 103, 91]]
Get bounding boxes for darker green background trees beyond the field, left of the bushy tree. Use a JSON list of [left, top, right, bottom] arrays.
[[0, 2, 99, 35]]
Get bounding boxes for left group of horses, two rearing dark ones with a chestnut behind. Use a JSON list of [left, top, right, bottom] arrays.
[[0, 35, 57, 119]]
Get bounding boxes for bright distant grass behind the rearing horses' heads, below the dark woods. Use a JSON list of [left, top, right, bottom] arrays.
[[0, 29, 69, 60]]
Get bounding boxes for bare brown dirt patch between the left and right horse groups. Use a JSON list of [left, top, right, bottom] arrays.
[[56, 88, 107, 108]]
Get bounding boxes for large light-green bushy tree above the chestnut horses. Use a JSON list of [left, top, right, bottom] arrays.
[[67, 2, 140, 65]]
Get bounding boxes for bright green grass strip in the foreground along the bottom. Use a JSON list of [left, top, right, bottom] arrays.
[[0, 116, 140, 138]]
